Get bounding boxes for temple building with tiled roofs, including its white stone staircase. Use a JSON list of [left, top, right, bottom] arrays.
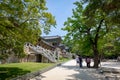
[[25, 36, 70, 62]]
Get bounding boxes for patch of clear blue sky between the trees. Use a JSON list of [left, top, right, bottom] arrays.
[[42, 0, 77, 36]]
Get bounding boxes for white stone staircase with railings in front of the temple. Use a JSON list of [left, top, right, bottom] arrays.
[[24, 43, 58, 62]]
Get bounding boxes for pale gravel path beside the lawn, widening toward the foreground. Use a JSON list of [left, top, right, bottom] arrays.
[[30, 60, 114, 80]]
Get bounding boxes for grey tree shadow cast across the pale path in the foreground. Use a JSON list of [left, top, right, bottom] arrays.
[[61, 65, 105, 80]]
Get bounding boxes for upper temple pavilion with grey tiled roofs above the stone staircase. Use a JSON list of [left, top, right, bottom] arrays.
[[34, 35, 69, 61]]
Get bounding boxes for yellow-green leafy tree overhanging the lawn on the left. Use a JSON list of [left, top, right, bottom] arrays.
[[0, 0, 56, 62]]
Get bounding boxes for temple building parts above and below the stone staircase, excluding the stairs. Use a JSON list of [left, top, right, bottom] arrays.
[[36, 36, 62, 62]]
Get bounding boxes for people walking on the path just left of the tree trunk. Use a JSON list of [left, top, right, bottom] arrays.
[[76, 55, 91, 68]]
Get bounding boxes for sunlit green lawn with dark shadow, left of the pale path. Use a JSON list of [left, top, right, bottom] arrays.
[[0, 62, 55, 80]]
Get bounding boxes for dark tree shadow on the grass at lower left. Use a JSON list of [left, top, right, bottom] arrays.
[[0, 67, 30, 80]]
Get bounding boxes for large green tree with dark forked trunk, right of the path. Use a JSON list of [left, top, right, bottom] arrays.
[[63, 0, 119, 68]]
